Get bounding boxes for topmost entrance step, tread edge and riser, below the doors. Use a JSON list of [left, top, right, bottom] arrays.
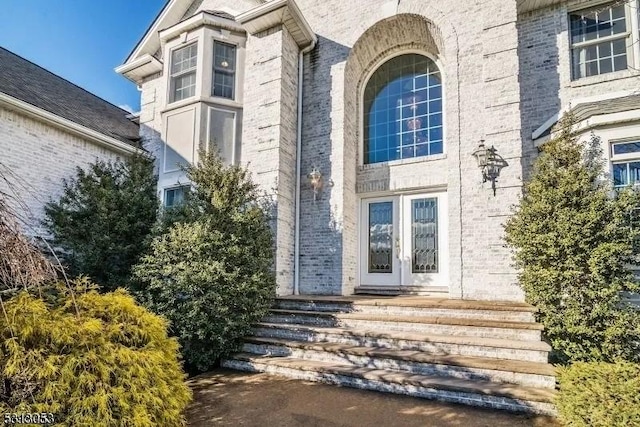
[[274, 296, 536, 322]]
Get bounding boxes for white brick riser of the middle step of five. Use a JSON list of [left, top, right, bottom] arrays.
[[254, 327, 548, 363]]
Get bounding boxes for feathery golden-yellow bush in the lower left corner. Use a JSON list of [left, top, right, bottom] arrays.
[[0, 279, 191, 427]]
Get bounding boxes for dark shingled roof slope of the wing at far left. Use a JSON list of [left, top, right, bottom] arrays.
[[0, 47, 139, 147]]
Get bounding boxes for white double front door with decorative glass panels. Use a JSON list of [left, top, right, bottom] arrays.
[[360, 193, 448, 287]]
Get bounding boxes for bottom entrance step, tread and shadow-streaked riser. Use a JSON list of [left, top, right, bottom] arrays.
[[222, 353, 555, 415]]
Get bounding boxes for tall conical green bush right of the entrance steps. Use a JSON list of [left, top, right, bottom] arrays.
[[506, 117, 640, 362]]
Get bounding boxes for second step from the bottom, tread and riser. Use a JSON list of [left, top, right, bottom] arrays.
[[243, 337, 556, 389]]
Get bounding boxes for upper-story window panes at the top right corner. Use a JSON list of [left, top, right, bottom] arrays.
[[569, 0, 639, 79]]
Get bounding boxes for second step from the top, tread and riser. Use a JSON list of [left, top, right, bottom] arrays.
[[264, 309, 543, 341]]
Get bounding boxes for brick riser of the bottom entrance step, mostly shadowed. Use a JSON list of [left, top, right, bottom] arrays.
[[222, 360, 555, 415]]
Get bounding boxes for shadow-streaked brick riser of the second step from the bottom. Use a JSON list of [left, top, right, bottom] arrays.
[[243, 343, 556, 388]]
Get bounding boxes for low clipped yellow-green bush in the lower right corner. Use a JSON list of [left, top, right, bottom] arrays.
[[556, 362, 640, 427]]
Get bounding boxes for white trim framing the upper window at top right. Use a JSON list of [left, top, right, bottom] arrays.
[[567, 0, 640, 82]]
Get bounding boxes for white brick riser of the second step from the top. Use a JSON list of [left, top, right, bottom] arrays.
[[264, 314, 541, 341]]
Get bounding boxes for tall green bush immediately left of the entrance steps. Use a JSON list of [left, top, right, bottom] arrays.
[[134, 153, 275, 371]]
